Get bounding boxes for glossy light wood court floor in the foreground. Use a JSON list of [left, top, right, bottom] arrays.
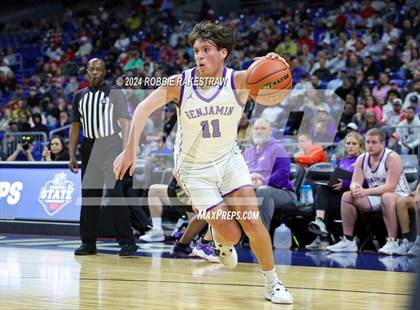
[[0, 247, 413, 310]]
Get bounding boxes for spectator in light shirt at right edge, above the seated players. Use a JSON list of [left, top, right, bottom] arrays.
[[397, 107, 420, 154]]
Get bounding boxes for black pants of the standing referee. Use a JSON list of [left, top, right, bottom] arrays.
[[80, 134, 134, 245]]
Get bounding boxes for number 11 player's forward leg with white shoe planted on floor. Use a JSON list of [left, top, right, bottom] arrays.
[[225, 187, 293, 304]]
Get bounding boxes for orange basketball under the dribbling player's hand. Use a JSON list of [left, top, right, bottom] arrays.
[[246, 59, 293, 106]]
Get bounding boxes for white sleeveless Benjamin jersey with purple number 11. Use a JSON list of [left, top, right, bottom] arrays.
[[174, 67, 244, 167]]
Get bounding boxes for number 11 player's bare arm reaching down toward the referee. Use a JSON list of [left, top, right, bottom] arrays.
[[114, 75, 181, 180]]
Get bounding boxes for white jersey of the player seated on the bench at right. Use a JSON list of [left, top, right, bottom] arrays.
[[362, 148, 410, 193]]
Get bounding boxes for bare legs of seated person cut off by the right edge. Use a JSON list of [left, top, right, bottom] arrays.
[[397, 184, 420, 256]]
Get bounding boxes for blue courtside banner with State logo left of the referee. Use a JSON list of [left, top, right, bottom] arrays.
[[0, 166, 81, 221]]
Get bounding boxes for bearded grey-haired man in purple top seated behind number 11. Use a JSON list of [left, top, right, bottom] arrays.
[[244, 118, 296, 231]]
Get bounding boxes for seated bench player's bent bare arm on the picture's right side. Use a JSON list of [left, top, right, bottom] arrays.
[[365, 152, 403, 195]]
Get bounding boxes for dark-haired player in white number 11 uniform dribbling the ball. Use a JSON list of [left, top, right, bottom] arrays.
[[114, 22, 293, 304]]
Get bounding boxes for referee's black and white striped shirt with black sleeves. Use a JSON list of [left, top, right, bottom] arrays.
[[73, 83, 130, 139]]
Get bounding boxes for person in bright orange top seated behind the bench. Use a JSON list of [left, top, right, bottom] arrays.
[[294, 134, 328, 168]]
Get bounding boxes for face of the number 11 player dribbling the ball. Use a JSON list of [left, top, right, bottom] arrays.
[[193, 39, 227, 76]]
